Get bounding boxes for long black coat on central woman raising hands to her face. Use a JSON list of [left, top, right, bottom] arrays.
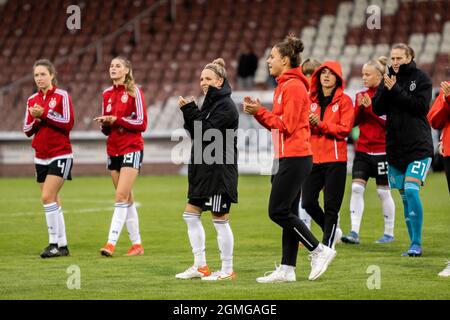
[[181, 80, 239, 203]]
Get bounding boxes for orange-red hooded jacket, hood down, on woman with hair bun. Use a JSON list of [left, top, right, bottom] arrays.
[[255, 67, 312, 158]]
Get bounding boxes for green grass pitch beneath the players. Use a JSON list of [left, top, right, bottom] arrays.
[[0, 174, 450, 300]]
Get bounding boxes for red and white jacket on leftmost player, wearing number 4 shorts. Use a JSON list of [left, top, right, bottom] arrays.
[[23, 87, 74, 161]]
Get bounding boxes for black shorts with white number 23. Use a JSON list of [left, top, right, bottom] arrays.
[[352, 152, 389, 186]]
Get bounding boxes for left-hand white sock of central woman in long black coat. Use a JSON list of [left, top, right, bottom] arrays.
[[183, 212, 206, 267]]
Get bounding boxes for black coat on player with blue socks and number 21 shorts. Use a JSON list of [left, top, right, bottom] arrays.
[[372, 61, 433, 171]]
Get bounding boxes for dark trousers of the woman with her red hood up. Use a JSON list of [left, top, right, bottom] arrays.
[[302, 162, 347, 247]]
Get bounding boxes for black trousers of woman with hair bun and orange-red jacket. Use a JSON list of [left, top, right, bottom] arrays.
[[269, 156, 319, 266]]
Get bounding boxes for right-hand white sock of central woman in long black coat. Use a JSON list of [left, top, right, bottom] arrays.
[[213, 219, 234, 274]]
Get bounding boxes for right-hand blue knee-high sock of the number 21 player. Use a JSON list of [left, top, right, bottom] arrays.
[[405, 181, 423, 246]]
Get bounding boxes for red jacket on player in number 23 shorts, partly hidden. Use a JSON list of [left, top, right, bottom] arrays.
[[354, 87, 386, 154]]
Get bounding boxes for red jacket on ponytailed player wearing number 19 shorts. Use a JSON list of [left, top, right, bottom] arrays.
[[102, 85, 147, 156]]
